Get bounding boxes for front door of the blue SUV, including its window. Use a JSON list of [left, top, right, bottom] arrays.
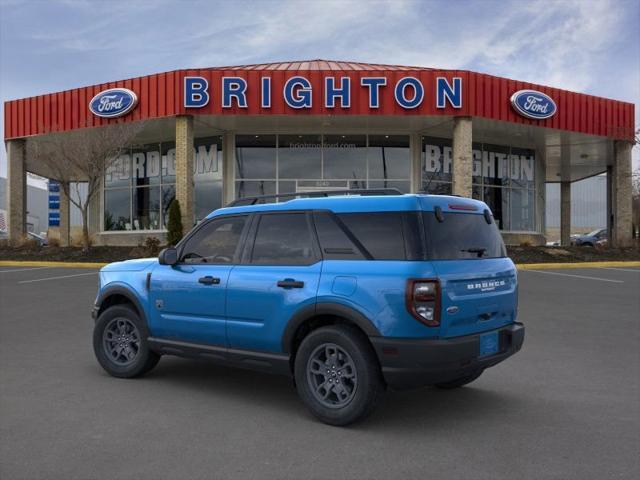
[[149, 215, 249, 345]]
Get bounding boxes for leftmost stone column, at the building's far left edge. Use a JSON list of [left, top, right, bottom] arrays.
[[7, 139, 27, 245]]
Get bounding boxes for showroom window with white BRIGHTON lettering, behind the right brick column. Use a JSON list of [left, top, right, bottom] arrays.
[[421, 137, 536, 232]]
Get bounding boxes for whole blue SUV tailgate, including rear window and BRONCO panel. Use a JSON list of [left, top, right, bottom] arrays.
[[423, 205, 518, 337]]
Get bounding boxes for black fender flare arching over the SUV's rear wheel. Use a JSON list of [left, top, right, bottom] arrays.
[[282, 302, 380, 353]]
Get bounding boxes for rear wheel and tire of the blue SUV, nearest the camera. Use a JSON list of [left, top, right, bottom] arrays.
[[294, 325, 384, 426]]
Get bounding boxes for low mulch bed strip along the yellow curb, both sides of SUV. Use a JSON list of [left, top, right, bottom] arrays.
[[0, 246, 640, 263]]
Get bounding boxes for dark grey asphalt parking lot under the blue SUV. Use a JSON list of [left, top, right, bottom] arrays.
[[0, 267, 640, 480]]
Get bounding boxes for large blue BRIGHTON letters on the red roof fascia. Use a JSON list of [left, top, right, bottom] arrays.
[[183, 76, 462, 110]]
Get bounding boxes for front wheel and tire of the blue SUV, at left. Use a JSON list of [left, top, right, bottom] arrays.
[[93, 305, 160, 378]]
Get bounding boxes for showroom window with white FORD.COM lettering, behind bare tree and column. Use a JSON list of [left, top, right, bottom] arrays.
[[103, 136, 222, 231]]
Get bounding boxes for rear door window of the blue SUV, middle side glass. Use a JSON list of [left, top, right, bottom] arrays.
[[251, 213, 316, 265]]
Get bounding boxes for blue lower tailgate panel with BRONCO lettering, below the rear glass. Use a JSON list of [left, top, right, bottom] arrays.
[[432, 258, 518, 337]]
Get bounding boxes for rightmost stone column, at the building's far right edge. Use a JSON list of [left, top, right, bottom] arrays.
[[611, 141, 632, 247]]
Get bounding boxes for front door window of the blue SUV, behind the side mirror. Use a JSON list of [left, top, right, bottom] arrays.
[[181, 215, 247, 264]]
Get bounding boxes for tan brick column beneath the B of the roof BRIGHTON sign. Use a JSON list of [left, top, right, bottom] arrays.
[[176, 115, 195, 235]]
